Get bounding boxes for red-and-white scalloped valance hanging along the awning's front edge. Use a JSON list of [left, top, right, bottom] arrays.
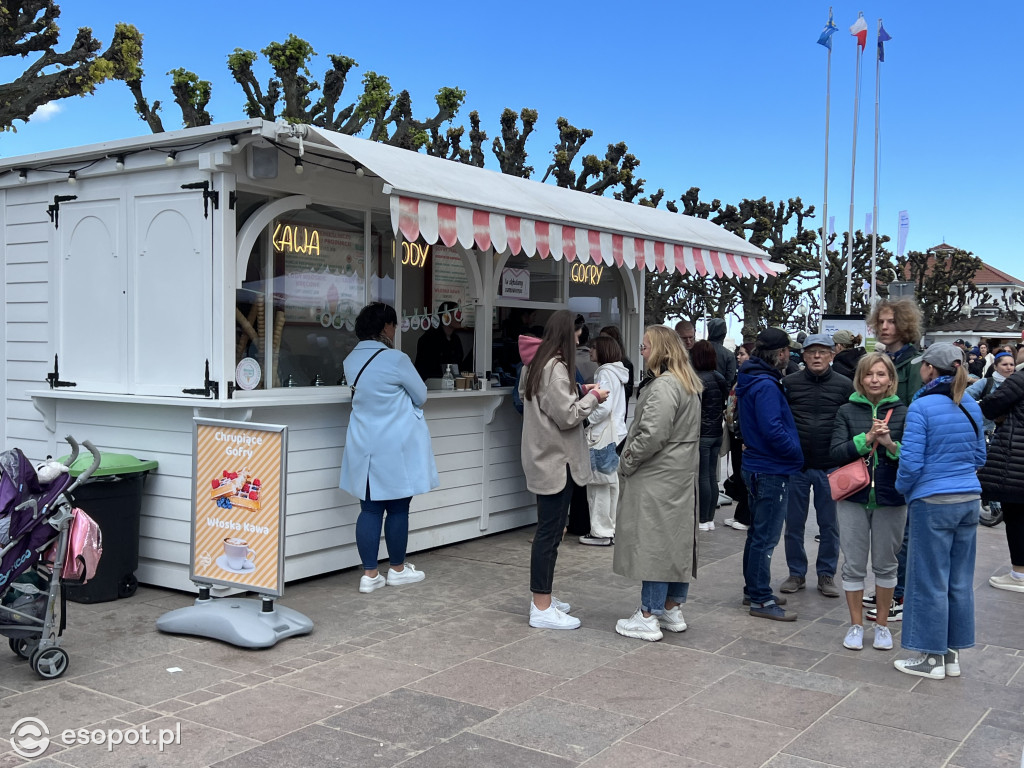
[[391, 195, 780, 278]]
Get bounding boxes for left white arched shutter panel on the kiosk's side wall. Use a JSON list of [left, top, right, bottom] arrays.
[[55, 200, 128, 392]]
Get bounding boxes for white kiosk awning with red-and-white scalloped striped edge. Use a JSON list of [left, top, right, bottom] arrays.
[[306, 128, 785, 278]]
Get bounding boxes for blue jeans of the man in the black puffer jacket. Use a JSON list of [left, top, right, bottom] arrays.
[[785, 469, 839, 579]]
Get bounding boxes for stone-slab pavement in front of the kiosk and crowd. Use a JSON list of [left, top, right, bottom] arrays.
[[0, 520, 1024, 768]]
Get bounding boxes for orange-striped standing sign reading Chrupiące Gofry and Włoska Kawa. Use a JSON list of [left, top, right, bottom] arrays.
[[190, 419, 288, 596]]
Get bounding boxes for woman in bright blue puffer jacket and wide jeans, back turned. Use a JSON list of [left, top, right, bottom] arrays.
[[893, 342, 985, 680]]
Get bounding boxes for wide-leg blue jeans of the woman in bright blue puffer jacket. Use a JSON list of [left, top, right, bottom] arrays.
[[901, 499, 981, 653]]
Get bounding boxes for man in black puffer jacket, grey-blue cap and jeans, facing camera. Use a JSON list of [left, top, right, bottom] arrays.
[[779, 334, 853, 597]]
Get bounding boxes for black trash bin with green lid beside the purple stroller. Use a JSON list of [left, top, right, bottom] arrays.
[[60, 454, 157, 603]]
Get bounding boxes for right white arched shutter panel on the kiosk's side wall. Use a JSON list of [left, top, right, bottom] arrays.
[[129, 191, 213, 395]]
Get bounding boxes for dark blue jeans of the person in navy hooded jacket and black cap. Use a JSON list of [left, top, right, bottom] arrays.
[[743, 469, 790, 605]]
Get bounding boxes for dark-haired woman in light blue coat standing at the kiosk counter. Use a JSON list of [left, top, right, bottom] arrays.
[[340, 302, 440, 593]]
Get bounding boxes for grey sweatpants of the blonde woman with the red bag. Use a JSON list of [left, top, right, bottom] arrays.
[[836, 502, 906, 592]]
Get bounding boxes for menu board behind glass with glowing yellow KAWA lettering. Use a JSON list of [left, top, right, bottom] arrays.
[[272, 219, 364, 330]]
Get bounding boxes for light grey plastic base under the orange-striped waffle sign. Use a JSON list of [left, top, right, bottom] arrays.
[[157, 597, 313, 648]]
